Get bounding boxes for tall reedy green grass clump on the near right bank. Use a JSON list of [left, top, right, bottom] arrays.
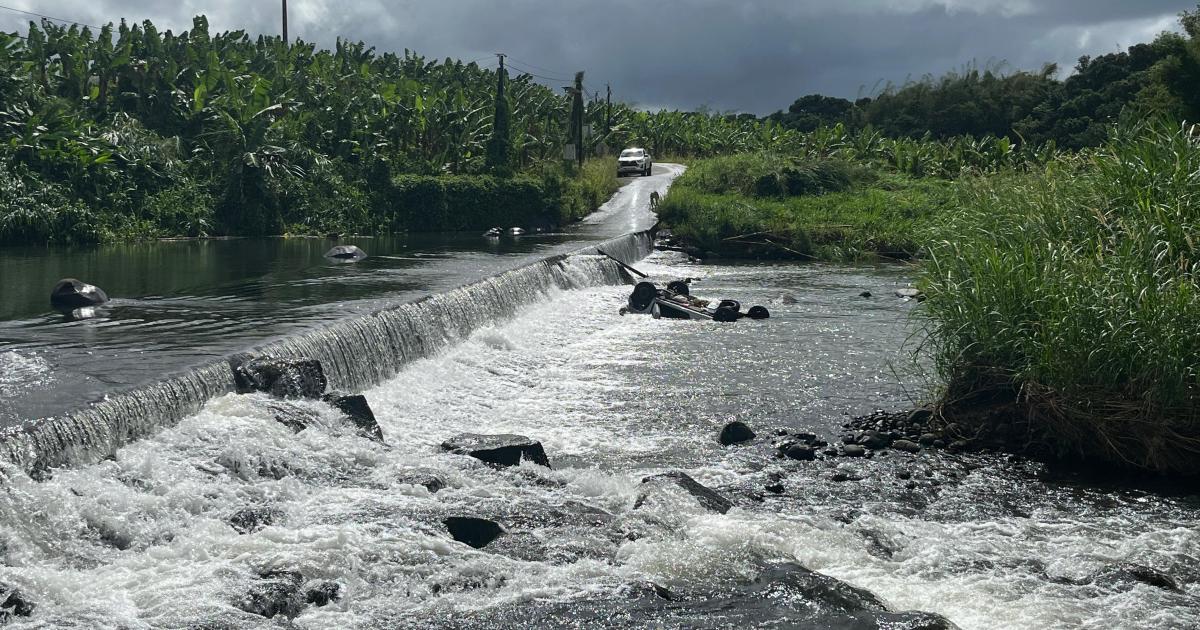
[[922, 117, 1200, 473]]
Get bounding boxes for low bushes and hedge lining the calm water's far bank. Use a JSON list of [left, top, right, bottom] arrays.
[[0, 158, 619, 245]]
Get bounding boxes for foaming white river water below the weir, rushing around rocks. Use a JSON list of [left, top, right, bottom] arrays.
[[0, 168, 1200, 629]]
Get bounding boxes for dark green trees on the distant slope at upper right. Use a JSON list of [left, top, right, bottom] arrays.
[[769, 10, 1200, 149]]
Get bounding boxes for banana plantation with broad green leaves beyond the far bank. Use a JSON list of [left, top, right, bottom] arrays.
[[0, 17, 1055, 242]]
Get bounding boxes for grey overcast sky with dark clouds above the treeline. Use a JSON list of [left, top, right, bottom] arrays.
[[0, 0, 1198, 114]]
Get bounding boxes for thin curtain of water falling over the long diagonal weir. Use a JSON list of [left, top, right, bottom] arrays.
[[0, 232, 652, 475]]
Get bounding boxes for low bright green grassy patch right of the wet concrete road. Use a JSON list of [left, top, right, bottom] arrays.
[[659, 154, 954, 260]]
